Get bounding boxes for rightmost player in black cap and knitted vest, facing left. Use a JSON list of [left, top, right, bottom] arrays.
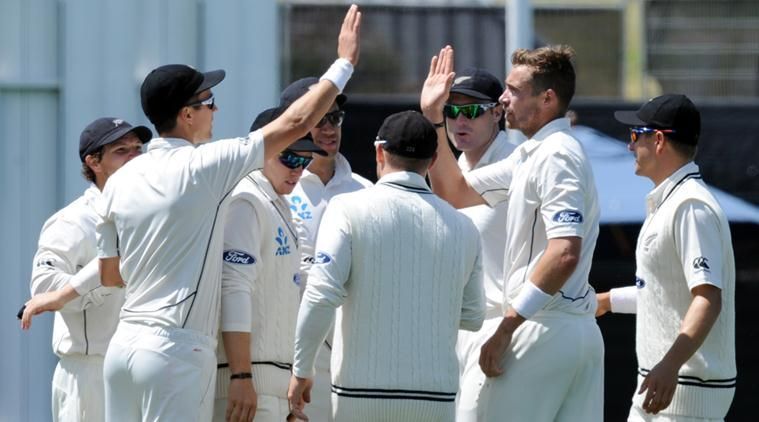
[[598, 94, 737, 422]]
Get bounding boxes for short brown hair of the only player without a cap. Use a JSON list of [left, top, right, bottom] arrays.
[[511, 45, 575, 115]]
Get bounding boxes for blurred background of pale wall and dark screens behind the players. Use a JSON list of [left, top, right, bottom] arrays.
[[0, 0, 759, 421]]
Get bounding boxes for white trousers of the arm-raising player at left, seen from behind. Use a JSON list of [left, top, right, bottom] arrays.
[[104, 322, 216, 422]]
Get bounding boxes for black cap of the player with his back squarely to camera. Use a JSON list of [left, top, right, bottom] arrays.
[[377, 111, 437, 159]]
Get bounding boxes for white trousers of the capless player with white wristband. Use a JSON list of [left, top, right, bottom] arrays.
[[478, 311, 604, 422]]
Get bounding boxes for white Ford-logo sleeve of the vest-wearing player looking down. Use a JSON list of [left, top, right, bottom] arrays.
[[220, 199, 261, 333]]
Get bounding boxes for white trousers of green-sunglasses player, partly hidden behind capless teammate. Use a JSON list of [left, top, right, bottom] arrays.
[[456, 317, 503, 422]]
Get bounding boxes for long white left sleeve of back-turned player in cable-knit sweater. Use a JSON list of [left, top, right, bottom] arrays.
[[293, 199, 352, 378]]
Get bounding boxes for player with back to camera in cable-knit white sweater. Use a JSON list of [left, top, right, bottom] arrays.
[[288, 111, 485, 422]]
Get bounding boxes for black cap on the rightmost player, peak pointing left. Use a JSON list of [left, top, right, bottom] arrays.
[[614, 94, 701, 145]]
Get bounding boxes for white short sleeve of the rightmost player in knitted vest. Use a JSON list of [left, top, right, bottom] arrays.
[[674, 200, 728, 289]]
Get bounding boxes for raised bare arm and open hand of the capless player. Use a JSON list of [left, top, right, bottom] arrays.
[[419, 45, 485, 208]]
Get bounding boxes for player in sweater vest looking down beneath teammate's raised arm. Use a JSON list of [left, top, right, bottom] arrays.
[[214, 108, 326, 422]]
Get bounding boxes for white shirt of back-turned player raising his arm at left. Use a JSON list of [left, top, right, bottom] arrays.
[[97, 134, 264, 339]]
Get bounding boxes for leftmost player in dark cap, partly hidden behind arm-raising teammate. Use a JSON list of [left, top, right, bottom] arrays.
[[26, 117, 152, 422]]
